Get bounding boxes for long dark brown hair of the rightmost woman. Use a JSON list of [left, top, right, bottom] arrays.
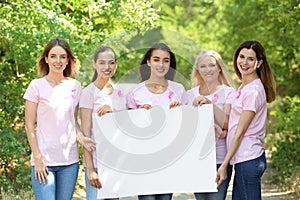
[[233, 40, 276, 103]]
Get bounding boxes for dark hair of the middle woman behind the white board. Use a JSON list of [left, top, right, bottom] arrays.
[[139, 43, 176, 82]]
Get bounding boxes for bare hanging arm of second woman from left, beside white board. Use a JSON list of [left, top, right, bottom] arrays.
[[80, 108, 102, 189]]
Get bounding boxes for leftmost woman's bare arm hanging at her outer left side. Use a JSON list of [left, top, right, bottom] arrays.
[[25, 100, 48, 184]]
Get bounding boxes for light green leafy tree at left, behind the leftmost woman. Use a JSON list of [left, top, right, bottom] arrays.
[[0, 0, 157, 193]]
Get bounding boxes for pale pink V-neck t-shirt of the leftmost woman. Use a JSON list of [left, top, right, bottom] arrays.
[[24, 77, 81, 166]]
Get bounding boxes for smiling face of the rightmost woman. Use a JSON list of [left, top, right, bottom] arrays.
[[236, 48, 262, 78]]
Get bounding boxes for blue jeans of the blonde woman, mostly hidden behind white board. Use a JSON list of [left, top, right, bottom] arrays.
[[194, 164, 232, 200]]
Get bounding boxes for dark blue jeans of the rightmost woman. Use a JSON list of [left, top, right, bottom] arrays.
[[232, 153, 267, 200]]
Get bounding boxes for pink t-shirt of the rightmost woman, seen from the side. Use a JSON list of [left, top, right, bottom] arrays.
[[227, 79, 267, 164]]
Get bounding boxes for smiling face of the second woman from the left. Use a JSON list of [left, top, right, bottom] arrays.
[[93, 51, 117, 78]]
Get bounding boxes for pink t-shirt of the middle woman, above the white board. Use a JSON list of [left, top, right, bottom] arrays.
[[127, 80, 185, 109]]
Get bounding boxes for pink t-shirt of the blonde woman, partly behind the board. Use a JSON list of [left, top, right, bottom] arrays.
[[185, 85, 236, 164]]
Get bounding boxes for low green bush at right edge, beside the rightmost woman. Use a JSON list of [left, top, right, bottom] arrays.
[[271, 96, 300, 186]]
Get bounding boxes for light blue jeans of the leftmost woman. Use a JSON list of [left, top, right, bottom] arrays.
[[31, 162, 79, 200]]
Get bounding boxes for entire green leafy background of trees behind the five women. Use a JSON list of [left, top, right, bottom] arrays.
[[0, 0, 300, 195]]
